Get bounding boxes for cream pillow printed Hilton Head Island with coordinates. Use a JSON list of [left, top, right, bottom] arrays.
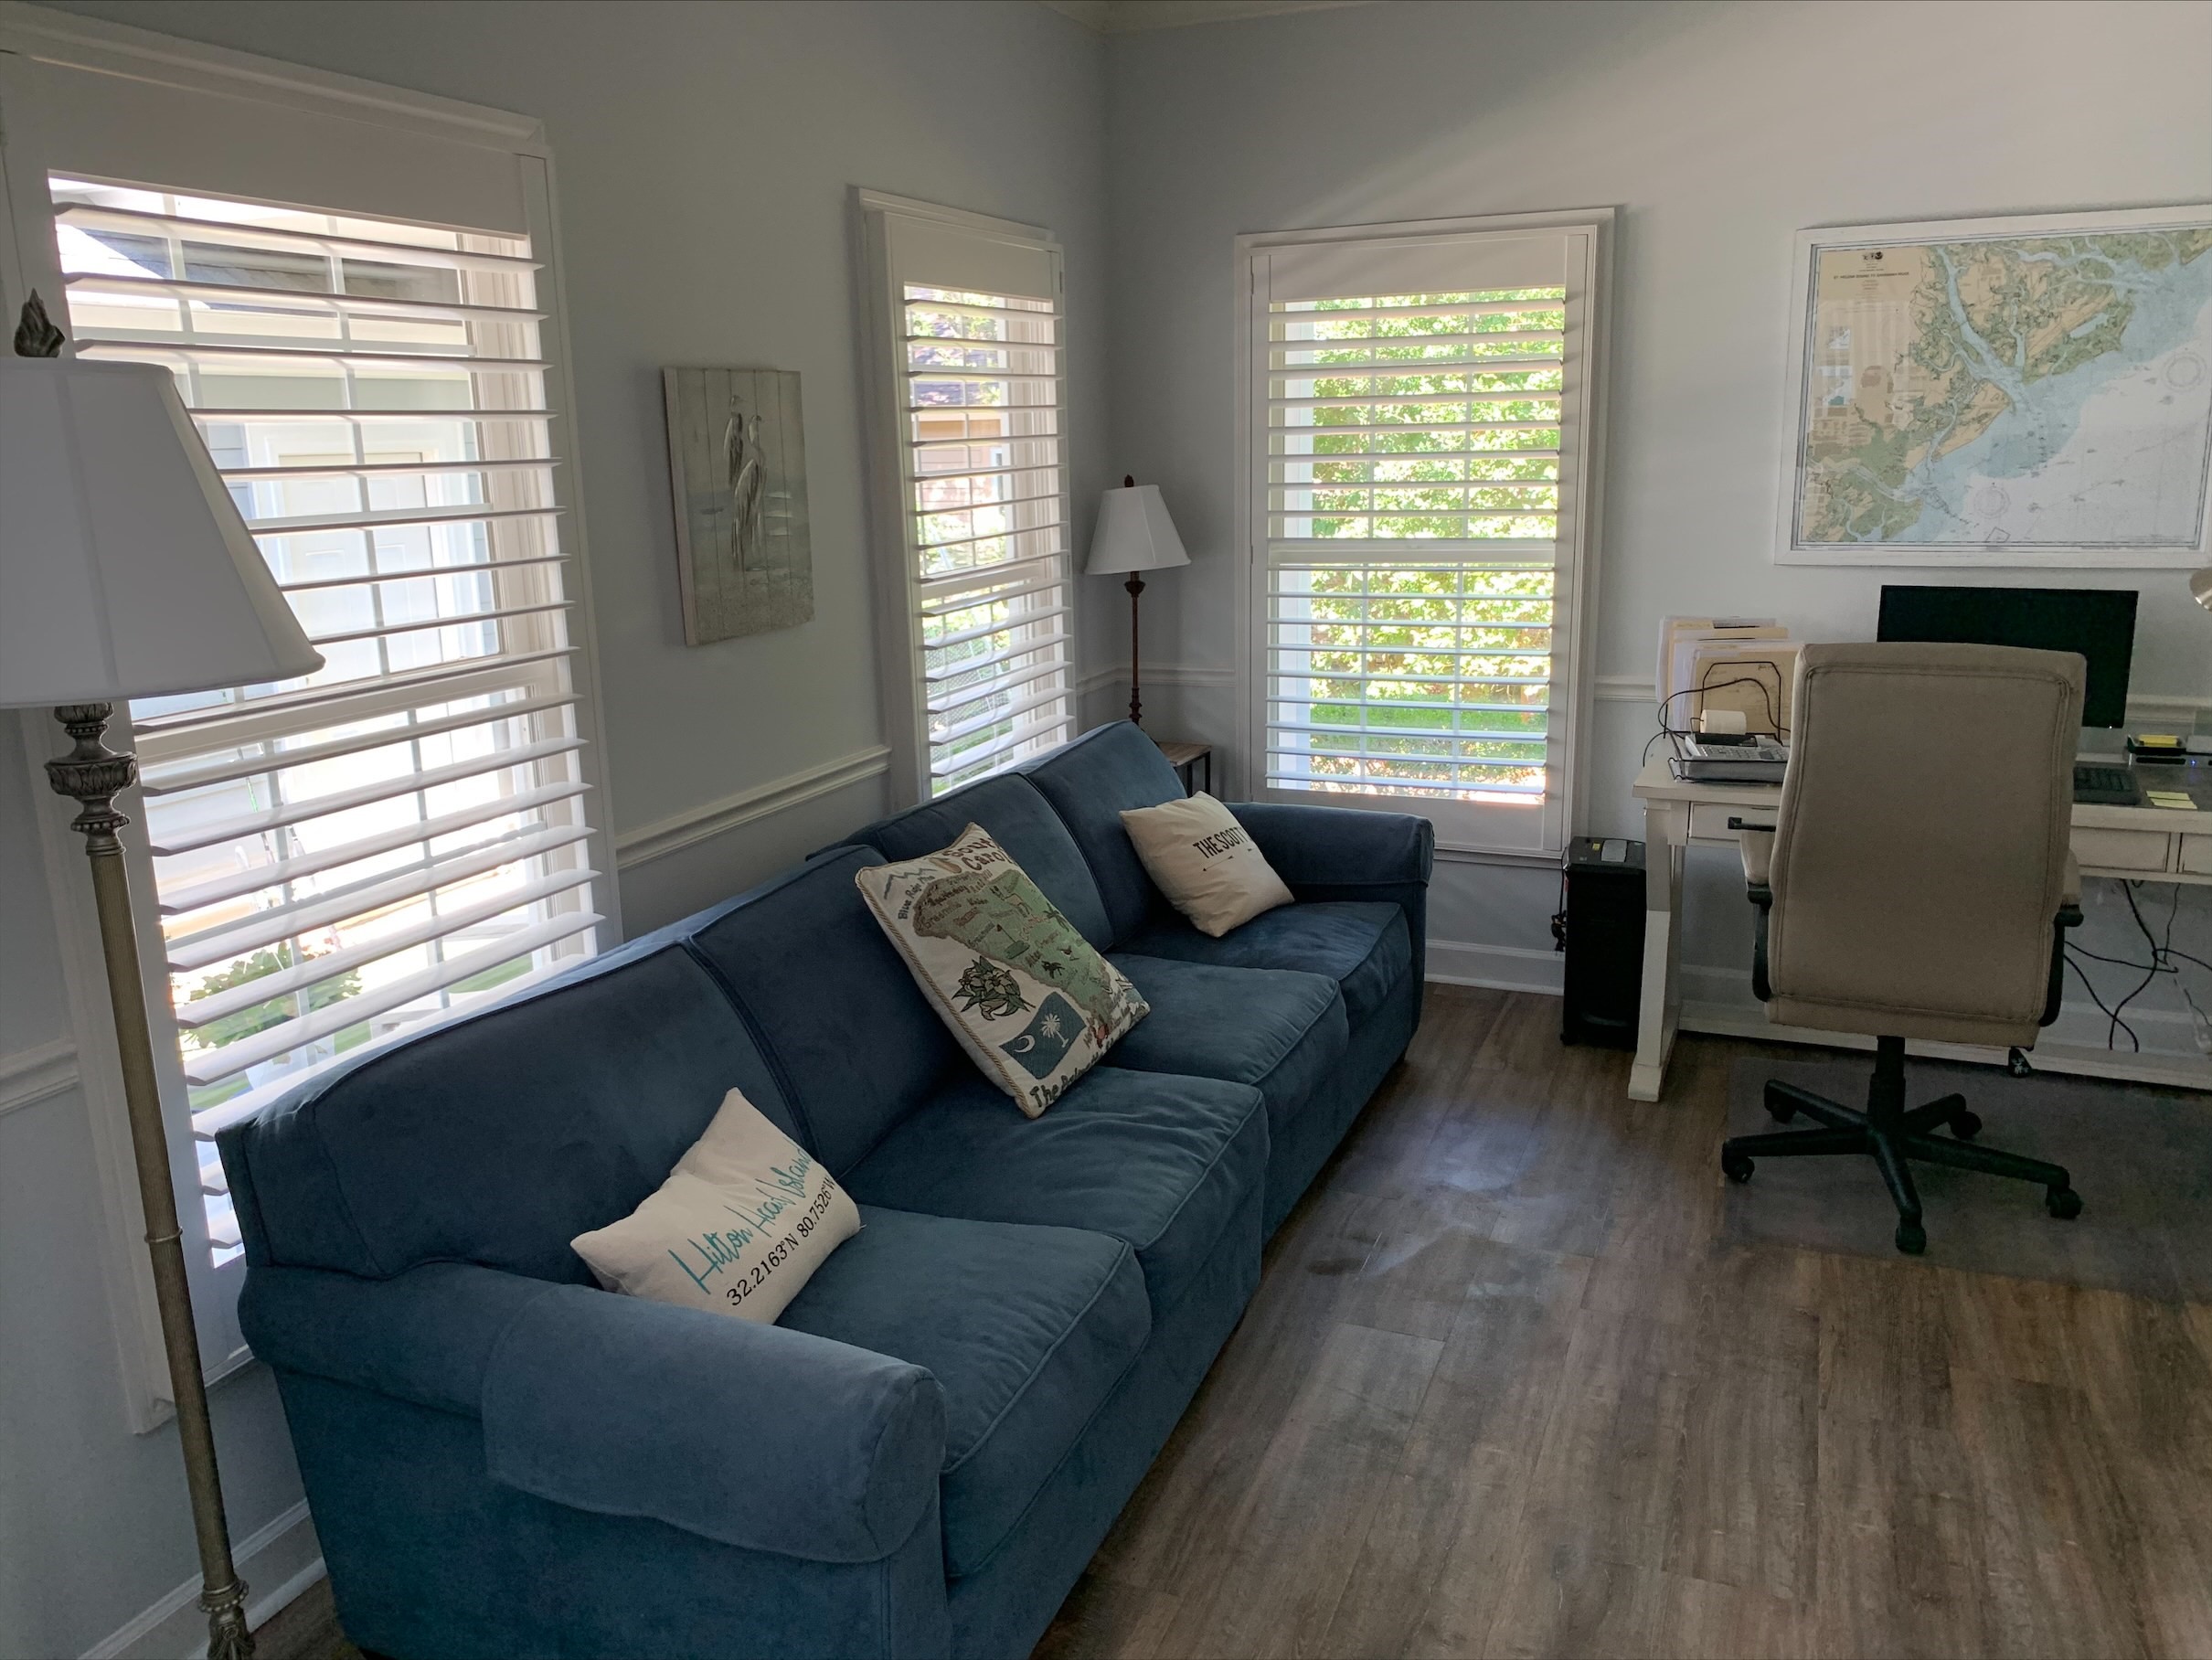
[[569, 1089, 860, 1322]]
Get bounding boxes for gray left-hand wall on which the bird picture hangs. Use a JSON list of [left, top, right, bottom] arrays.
[[0, 0, 1106, 1655]]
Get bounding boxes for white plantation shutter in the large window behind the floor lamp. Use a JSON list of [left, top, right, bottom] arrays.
[[51, 177, 609, 1261]]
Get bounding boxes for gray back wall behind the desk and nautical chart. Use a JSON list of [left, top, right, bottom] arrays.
[[1108, 0, 2212, 1042]]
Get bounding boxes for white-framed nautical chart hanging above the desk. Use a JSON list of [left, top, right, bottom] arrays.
[[1776, 206, 2212, 569]]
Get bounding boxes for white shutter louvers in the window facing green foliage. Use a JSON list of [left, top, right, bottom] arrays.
[[1257, 285, 1570, 805]]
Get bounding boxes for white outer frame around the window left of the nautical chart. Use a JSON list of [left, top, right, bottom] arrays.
[[1234, 208, 1615, 863]]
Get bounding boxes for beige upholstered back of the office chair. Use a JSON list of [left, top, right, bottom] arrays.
[[1768, 644, 2084, 1045]]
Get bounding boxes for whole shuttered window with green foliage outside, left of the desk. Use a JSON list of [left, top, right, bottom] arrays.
[[1245, 221, 1604, 852]]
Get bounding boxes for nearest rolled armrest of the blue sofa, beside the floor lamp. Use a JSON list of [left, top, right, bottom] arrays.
[[239, 1264, 944, 1562]]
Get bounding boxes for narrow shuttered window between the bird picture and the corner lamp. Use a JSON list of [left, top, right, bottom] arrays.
[[863, 193, 1075, 802]]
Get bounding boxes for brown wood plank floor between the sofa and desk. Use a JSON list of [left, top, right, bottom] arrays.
[[261, 987, 2212, 1660]]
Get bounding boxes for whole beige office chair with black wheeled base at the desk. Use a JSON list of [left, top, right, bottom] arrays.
[[1721, 644, 2084, 1255]]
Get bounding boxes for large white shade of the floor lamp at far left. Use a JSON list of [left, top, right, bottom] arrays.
[[0, 356, 323, 706]]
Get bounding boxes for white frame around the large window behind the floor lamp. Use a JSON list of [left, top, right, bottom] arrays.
[[0, 5, 622, 1432]]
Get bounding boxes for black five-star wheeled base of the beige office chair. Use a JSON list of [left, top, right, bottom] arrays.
[[1721, 1038, 2081, 1257]]
